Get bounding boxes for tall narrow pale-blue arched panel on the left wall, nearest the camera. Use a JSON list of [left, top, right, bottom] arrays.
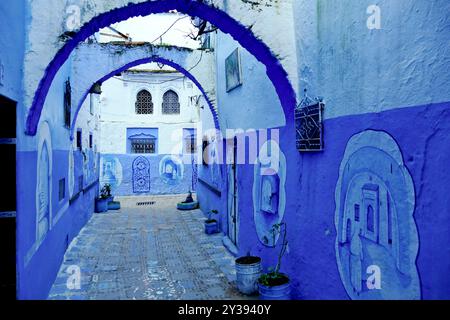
[[36, 121, 53, 246]]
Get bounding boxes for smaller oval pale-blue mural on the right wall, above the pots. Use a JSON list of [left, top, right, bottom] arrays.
[[253, 140, 286, 247]]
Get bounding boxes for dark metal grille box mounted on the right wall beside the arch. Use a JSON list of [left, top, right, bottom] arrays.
[[295, 89, 325, 152]]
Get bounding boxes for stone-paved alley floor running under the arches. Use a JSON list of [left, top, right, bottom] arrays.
[[49, 196, 250, 300]]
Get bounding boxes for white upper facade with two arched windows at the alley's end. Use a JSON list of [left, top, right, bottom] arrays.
[[100, 73, 201, 154]]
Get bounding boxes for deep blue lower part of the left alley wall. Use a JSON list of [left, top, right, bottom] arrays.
[[17, 151, 97, 299]]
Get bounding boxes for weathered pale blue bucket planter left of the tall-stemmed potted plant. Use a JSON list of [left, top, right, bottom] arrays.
[[235, 252, 262, 295]]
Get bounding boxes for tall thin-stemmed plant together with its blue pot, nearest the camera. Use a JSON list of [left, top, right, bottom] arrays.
[[258, 222, 291, 300]]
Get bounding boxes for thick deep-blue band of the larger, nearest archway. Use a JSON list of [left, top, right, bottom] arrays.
[[26, 0, 296, 135]]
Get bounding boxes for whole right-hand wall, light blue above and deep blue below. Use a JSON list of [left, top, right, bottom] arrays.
[[214, 0, 450, 299]]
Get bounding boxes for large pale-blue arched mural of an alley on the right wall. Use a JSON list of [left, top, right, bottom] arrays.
[[335, 130, 421, 300]]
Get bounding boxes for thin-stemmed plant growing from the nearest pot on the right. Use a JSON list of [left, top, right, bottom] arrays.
[[258, 222, 289, 286]]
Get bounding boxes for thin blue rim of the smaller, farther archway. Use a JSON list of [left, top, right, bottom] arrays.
[[70, 56, 220, 140]]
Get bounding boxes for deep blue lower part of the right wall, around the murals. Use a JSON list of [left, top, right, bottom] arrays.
[[234, 103, 450, 299]]
